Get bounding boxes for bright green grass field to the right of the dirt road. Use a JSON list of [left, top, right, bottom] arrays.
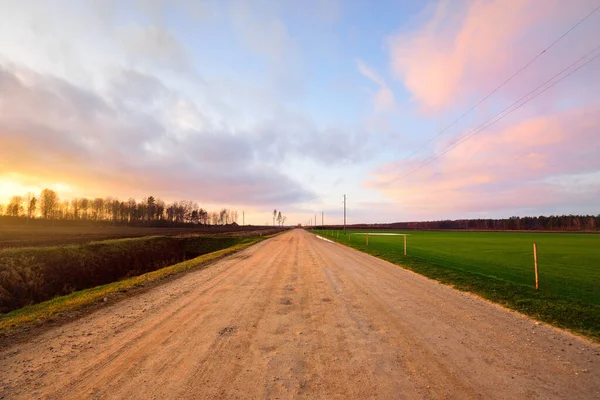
[[314, 231, 600, 340]]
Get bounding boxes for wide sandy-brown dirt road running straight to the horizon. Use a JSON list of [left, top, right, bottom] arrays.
[[0, 230, 600, 399]]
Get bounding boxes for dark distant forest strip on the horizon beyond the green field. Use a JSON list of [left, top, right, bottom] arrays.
[[342, 214, 600, 232]]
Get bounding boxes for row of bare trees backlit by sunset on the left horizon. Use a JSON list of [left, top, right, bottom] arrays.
[[0, 189, 243, 226]]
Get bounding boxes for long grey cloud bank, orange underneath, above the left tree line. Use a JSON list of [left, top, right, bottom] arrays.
[[0, 54, 377, 206]]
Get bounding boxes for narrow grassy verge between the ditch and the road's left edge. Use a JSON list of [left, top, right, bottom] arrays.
[[0, 235, 262, 334]]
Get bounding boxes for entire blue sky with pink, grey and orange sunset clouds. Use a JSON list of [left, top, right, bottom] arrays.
[[0, 0, 600, 224]]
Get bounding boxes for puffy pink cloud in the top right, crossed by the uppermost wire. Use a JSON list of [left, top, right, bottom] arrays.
[[388, 0, 600, 113]]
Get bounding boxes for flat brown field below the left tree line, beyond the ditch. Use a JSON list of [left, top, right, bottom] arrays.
[[0, 224, 273, 249]]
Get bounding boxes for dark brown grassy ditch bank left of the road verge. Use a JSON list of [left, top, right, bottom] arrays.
[[0, 235, 243, 313]]
